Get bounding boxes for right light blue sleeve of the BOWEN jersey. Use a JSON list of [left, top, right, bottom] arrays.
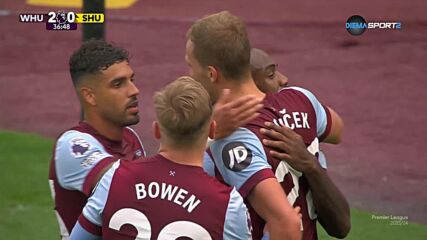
[[223, 188, 252, 240]]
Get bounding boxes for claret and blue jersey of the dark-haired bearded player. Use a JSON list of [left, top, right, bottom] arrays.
[[49, 122, 145, 236]]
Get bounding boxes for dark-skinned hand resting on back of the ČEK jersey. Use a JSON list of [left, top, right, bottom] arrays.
[[260, 122, 320, 174]]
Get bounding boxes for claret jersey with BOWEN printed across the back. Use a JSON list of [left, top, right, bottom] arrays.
[[71, 154, 251, 240]]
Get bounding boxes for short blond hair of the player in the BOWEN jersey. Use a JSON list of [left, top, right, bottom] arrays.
[[153, 76, 213, 147]]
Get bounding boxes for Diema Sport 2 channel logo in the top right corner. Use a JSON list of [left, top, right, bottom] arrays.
[[345, 15, 402, 36]]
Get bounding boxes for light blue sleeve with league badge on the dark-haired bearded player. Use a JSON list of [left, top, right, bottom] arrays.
[[55, 130, 111, 192]]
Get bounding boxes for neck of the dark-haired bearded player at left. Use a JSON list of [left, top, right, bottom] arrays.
[[84, 114, 123, 141]]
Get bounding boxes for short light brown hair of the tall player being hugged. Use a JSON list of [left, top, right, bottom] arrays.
[[187, 11, 251, 80]]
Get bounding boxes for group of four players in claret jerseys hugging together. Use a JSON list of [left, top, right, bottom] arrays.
[[49, 11, 350, 240]]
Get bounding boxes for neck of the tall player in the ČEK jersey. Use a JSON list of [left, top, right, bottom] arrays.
[[223, 78, 265, 100]]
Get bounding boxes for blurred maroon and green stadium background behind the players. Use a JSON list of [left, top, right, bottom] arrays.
[[0, 0, 427, 239]]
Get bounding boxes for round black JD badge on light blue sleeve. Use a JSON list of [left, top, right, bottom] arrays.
[[222, 142, 252, 172]]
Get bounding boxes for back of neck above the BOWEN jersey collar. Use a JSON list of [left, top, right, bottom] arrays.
[[159, 144, 205, 167]]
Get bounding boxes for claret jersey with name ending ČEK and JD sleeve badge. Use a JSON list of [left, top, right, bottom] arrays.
[[204, 87, 331, 239]]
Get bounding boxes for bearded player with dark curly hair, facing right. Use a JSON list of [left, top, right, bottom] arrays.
[[49, 40, 145, 239]]
